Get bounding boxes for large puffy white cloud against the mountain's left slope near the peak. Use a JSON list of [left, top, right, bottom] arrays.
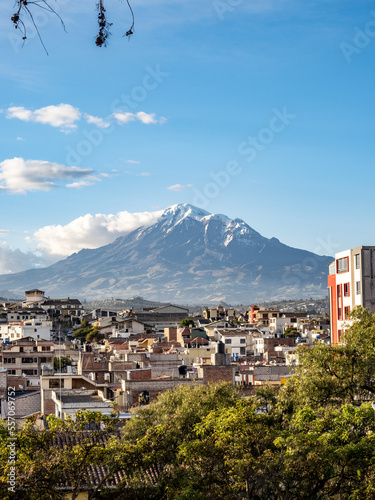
[[34, 210, 163, 257]]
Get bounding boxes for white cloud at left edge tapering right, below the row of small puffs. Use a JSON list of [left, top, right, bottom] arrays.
[[0, 158, 95, 194]]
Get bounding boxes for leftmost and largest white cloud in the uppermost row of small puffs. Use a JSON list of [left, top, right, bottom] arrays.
[[6, 103, 81, 131]]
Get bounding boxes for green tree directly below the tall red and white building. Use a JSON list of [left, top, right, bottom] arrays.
[[279, 308, 375, 413]]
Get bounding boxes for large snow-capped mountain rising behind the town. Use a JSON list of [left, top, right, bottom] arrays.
[[0, 204, 332, 304]]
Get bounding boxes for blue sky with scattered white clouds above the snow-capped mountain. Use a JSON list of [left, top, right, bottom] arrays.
[[0, 0, 375, 272]]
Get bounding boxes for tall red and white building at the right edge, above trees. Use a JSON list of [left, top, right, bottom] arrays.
[[328, 246, 375, 344]]
